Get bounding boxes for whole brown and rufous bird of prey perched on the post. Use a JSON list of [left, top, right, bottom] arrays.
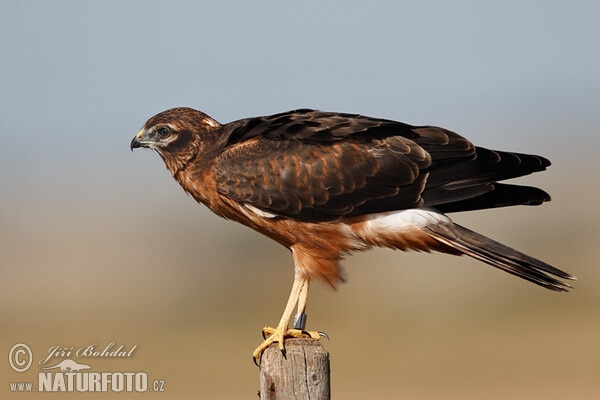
[[131, 107, 576, 360]]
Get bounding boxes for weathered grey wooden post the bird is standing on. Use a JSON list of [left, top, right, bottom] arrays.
[[260, 339, 330, 400]]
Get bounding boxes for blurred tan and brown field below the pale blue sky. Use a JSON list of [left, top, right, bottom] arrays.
[[0, 154, 600, 399]]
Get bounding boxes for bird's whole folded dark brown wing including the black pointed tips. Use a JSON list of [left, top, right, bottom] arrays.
[[214, 110, 550, 221]]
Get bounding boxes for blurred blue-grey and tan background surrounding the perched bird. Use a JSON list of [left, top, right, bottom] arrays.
[[0, 0, 600, 399]]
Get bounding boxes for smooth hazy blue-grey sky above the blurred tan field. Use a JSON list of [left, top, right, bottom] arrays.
[[0, 1, 600, 203]]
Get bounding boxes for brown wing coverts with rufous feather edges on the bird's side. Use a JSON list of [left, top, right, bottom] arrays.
[[215, 138, 429, 220]]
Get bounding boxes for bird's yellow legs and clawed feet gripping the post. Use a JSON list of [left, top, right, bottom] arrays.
[[252, 278, 319, 360]]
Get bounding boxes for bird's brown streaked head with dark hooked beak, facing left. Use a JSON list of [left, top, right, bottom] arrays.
[[131, 107, 221, 174]]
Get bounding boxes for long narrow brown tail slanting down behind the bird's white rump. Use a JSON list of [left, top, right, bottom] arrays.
[[423, 222, 577, 292]]
